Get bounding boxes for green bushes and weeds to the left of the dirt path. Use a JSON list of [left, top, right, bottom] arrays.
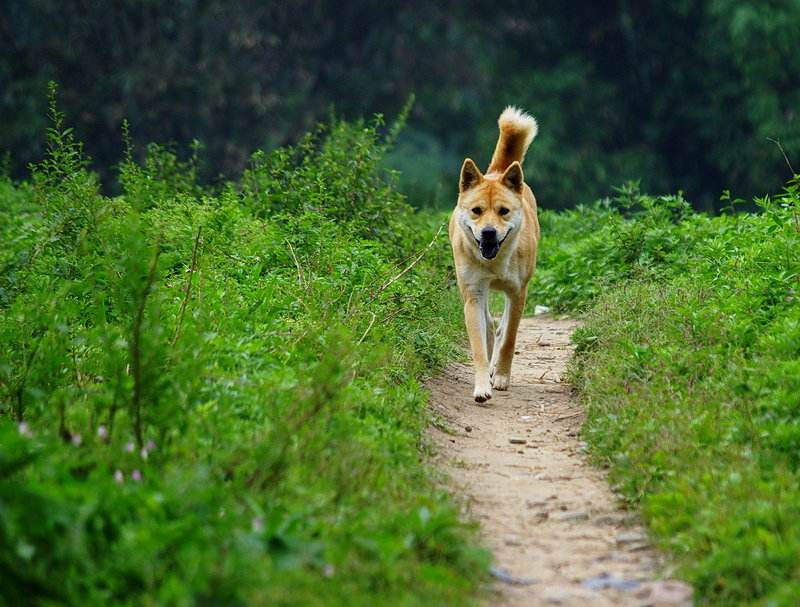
[[0, 97, 487, 605]]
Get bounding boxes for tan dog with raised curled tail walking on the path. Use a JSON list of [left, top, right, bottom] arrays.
[[449, 106, 539, 403]]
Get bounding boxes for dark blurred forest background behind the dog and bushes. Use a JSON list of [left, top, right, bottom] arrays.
[[0, 0, 800, 209]]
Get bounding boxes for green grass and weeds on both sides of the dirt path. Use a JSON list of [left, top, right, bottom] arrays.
[[6, 86, 800, 605]]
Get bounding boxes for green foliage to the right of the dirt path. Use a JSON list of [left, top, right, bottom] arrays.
[[532, 176, 800, 606]]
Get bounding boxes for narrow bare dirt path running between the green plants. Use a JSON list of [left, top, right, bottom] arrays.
[[430, 316, 689, 606]]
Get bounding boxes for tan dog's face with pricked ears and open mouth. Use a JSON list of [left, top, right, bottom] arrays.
[[458, 158, 525, 259]]
